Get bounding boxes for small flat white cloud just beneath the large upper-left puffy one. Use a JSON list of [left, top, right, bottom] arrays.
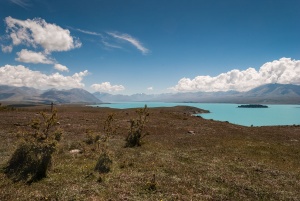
[[16, 49, 54, 64]]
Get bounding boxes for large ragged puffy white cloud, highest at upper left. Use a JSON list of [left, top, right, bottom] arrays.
[[5, 17, 81, 53]]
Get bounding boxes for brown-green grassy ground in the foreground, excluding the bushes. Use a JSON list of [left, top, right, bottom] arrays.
[[0, 106, 300, 200]]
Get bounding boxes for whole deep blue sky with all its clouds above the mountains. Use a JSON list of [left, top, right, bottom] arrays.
[[0, 0, 300, 94]]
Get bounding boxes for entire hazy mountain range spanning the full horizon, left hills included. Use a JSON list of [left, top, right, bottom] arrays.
[[0, 84, 300, 104]]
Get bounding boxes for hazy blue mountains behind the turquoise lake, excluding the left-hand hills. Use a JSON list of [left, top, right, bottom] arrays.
[[94, 84, 300, 104]]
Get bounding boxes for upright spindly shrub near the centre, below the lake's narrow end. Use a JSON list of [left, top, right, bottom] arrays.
[[125, 105, 149, 147]]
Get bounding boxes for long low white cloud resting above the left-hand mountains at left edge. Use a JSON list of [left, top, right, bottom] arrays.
[[0, 65, 88, 89]]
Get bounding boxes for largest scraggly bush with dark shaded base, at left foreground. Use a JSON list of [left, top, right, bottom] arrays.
[[4, 111, 62, 183]]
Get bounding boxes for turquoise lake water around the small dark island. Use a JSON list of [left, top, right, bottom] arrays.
[[94, 102, 300, 126]]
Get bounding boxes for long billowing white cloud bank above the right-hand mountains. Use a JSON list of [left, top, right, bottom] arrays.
[[170, 58, 300, 91]]
